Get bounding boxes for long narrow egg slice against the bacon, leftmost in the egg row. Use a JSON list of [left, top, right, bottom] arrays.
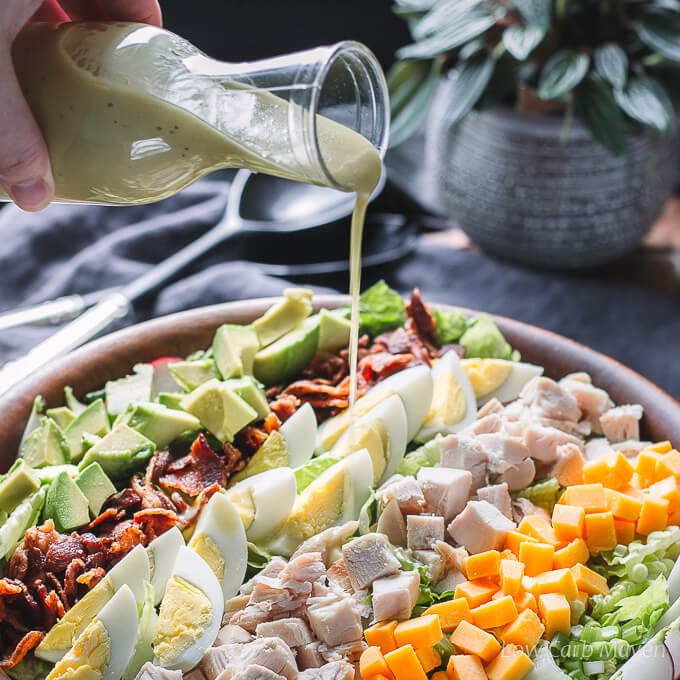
[[35, 545, 150, 663]]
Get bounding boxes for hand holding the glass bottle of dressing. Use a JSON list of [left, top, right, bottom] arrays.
[[0, 0, 162, 210]]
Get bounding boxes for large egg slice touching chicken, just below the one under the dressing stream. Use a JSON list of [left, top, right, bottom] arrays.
[[267, 449, 373, 556]]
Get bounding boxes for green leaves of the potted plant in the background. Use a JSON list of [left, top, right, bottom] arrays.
[[388, 0, 680, 156]]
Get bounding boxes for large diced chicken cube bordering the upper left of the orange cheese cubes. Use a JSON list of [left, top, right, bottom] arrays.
[[448, 501, 515, 554]]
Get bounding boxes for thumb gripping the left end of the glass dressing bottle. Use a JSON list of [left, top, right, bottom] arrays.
[[0, 44, 54, 211]]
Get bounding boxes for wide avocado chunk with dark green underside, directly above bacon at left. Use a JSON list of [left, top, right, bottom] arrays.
[[78, 423, 156, 481]]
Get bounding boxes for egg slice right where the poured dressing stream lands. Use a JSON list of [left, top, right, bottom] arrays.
[[331, 394, 408, 484]]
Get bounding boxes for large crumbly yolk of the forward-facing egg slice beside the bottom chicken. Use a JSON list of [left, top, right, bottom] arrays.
[[153, 576, 213, 666]]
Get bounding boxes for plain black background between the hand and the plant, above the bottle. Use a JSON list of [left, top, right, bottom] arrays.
[[161, 0, 409, 67]]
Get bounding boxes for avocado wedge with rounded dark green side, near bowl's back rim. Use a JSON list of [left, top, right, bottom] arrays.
[[253, 316, 319, 385]]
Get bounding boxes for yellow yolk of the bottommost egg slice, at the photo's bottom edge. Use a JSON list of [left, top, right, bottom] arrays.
[[46, 619, 111, 680]]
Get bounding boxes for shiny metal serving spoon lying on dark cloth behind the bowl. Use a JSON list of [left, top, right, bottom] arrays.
[[0, 170, 384, 394]]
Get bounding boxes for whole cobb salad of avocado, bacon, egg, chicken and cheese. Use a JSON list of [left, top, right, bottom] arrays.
[[0, 282, 680, 680]]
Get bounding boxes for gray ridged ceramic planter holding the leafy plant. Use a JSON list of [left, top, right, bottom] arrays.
[[426, 82, 677, 268]]
